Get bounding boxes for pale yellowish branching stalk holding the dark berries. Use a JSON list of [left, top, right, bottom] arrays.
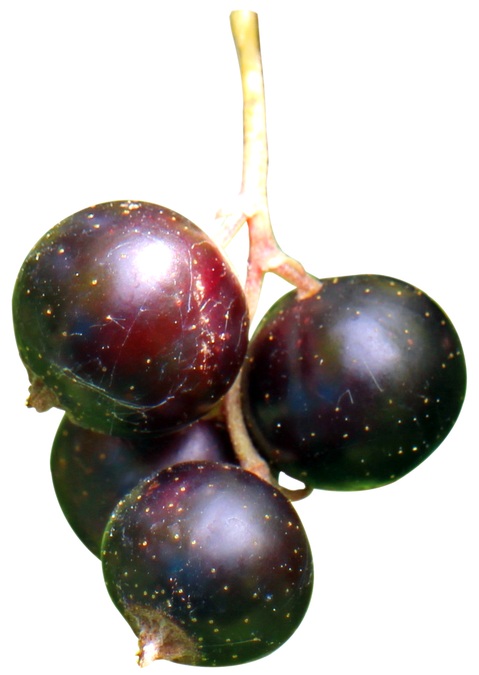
[[213, 9, 322, 499]]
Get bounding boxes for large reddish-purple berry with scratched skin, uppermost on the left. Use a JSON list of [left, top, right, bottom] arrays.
[[12, 200, 248, 436]]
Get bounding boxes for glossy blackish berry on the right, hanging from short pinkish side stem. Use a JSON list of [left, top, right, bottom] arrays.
[[242, 274, 467, 492]]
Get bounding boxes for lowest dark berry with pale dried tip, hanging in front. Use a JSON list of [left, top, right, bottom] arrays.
[[101, 462, 314, 668]]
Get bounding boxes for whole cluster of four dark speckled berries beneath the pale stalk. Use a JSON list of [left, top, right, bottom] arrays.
[[11, 200, 467, 668]]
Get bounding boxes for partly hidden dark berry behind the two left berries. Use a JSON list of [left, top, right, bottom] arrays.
[[49, 414, 236, 559]]
